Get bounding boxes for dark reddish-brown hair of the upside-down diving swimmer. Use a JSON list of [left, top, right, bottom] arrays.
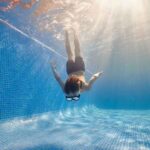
[[64, 76, 80, 94]]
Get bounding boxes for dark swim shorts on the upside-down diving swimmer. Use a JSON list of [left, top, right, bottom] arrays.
[[66, 56, 85, 75]]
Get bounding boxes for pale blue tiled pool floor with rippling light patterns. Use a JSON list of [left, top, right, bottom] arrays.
[[0, 106, 150, 150]]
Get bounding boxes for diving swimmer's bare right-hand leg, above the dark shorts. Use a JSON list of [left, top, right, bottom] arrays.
[[73, 29, 82, 57]]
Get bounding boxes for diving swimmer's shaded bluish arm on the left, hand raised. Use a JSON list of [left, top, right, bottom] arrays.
[[51, 62, 64, 91]]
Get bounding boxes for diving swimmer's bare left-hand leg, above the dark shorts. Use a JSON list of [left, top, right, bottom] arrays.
[[65, 31, 73, 60]]
